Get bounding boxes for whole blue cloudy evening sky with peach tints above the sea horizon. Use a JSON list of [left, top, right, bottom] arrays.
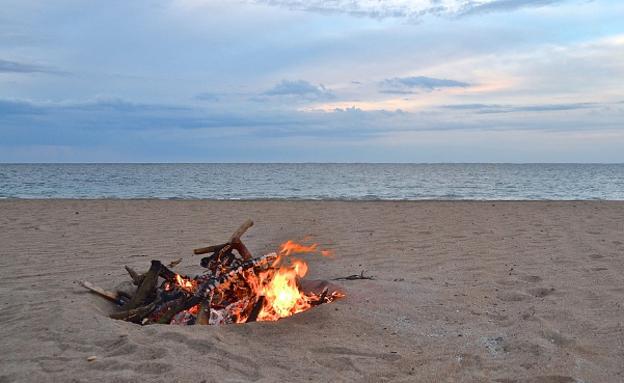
[[0, 0, 624, 163]]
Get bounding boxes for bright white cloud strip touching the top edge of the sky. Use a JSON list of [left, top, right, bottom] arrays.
[[251, 0, 566, 21]]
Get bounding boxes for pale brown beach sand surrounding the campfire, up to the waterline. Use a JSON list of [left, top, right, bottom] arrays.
[[0, 200, 624, 383]]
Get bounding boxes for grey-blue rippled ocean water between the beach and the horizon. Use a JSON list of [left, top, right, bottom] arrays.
[[0, 164, 624, 200]]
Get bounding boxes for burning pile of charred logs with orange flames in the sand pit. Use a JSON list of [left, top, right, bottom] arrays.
[[81, 220, 344, 325]]
